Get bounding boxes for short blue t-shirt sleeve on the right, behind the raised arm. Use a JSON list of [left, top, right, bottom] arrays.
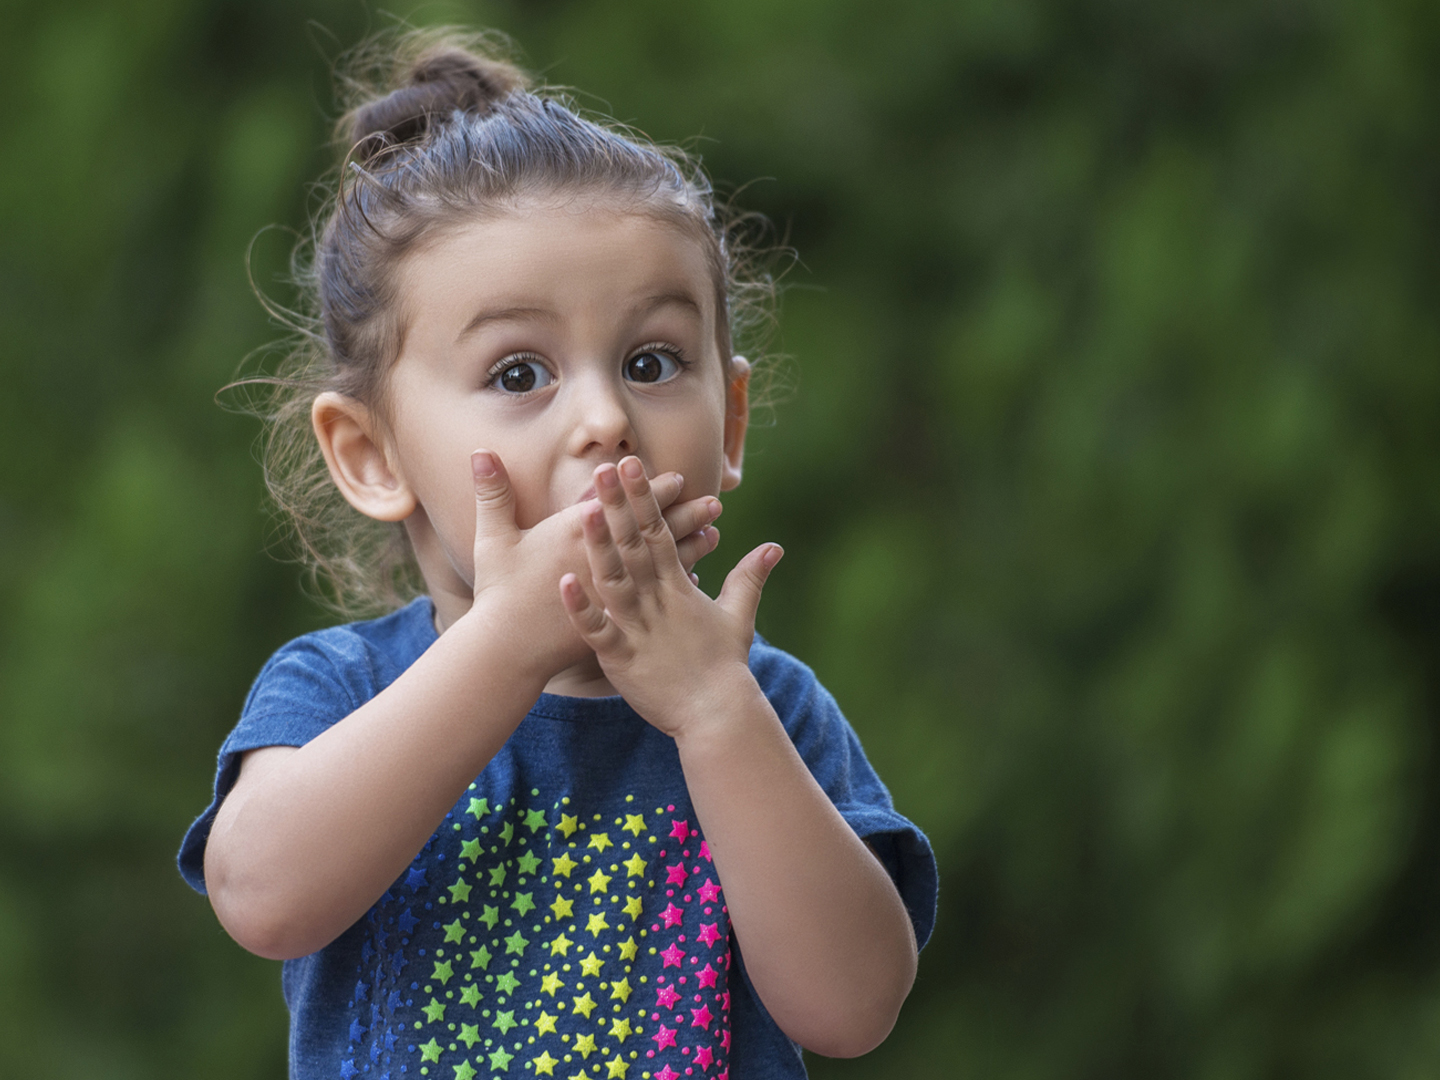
[[750, 636, 939, 946]]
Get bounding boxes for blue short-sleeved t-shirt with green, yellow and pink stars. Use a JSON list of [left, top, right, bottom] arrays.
[[180, 598, 937, 1080]]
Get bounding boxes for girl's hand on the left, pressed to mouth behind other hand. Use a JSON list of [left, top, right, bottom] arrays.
[[471, 449, 721, 674]]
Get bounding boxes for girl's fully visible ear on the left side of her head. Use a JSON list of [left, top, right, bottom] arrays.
[[310, 390, 416, 521]]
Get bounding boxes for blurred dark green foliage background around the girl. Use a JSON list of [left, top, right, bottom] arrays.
[[0, 0, 1440, 1080]]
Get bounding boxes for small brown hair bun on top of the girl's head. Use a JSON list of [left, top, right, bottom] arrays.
[[347, 46, 527, 158]]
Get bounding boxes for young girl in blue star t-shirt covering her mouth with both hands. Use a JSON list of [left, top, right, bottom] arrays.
[[180, 29, 936, 1080]]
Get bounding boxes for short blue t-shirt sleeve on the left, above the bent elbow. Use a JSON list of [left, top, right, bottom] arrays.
[[179, 636, 360, 894]]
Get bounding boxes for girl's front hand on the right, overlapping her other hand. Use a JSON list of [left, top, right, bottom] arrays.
[[560, 456, 783, 737]]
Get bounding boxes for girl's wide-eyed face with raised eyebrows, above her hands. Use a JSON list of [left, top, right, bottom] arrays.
[[384, 207, 747, 616]]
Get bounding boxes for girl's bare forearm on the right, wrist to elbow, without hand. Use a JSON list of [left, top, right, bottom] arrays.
[[677, 671, 916, 1057]]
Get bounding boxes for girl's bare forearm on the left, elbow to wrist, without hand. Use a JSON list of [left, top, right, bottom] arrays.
[[204, 601, 546, 959]]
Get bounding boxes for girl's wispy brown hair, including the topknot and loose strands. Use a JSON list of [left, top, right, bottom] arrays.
[[242, 30, 773, 616]]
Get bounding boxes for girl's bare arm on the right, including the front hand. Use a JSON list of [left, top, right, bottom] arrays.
[[560, 458, 916, 1057]]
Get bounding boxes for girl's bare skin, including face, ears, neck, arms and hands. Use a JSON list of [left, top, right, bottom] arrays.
[[206, 204, 916, 1056]]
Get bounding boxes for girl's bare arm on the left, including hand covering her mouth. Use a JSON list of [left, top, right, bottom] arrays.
[[204, 467, 714, 959]]
